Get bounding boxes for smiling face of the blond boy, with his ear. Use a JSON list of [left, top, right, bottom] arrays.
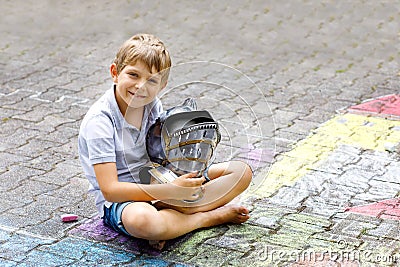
[[111, 60, 166, 108]]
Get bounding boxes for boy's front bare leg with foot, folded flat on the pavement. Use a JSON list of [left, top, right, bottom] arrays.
[[122, 202, 249, 243]]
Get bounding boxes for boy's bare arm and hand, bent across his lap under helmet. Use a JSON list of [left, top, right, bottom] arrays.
[[93, 162, 205, 202]]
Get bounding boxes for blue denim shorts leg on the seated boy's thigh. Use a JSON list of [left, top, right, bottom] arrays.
[[103, 201, 133, 236]]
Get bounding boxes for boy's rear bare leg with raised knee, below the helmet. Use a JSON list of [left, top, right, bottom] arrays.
[[156, 161, 252, 214]]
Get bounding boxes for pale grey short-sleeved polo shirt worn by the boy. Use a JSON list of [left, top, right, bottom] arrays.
[[78, 86, 162, 217]]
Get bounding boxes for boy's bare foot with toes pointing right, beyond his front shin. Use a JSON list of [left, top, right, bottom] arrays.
[[205, 205, 250, 226]]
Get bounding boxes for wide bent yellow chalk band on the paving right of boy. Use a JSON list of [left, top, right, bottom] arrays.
[[252, 113, 400, 197]]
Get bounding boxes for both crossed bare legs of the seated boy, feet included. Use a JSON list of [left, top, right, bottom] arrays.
[[122, 161, 252, 249]]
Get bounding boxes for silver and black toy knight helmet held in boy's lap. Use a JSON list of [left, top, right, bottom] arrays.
[[146, 98, 221, 176]]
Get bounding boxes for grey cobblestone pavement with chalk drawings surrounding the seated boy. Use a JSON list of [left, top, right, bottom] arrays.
[[0, 0, 400, 266]]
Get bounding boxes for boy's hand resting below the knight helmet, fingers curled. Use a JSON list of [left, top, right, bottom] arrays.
[[172, 173, 206, 201]]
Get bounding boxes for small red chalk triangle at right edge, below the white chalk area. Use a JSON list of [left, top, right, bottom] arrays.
[[345, 198, 400, 220]]
